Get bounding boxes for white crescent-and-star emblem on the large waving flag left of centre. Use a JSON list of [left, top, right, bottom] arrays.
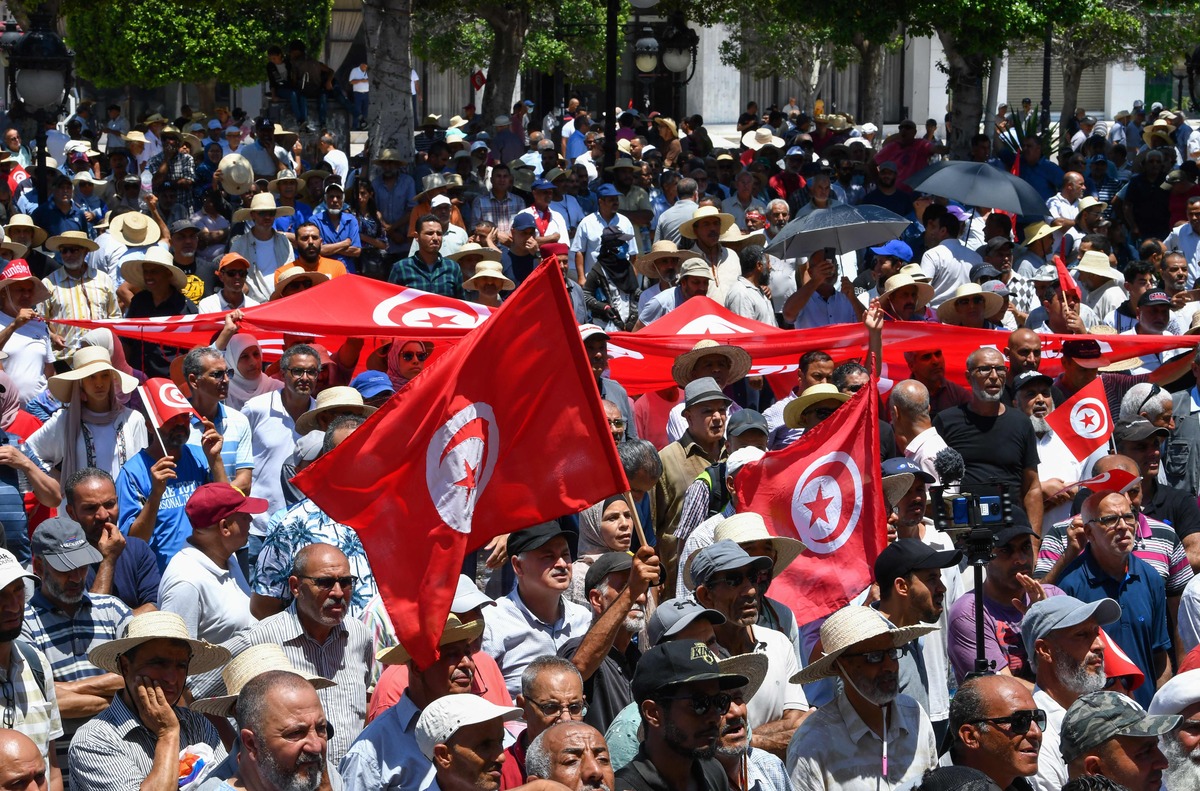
[[425, 401, 500, 533]]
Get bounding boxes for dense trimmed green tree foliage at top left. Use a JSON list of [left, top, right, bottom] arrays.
[[61, 0, 334, 88]]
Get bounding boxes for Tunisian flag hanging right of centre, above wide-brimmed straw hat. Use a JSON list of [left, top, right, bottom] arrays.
[[736, 378, 888, 623]]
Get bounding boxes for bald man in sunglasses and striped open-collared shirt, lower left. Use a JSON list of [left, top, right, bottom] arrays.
[[224, 544, 372, 768]]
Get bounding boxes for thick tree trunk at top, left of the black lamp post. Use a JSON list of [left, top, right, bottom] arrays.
[[362, 0, 415, 162]]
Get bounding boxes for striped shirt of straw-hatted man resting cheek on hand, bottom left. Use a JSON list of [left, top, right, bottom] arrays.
[[68, 695, 227, 791]]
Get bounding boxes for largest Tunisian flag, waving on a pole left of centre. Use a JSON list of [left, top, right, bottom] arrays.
[[294, 263, 629, 667]]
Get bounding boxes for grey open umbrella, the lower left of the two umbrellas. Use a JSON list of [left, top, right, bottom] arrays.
[[767, 204, 910, 257]]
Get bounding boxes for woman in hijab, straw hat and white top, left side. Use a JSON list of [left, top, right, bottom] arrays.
[[28, 346, 149, 489]]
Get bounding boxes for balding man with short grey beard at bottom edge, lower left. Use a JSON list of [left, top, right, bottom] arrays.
[[206, 670, 330, 791]]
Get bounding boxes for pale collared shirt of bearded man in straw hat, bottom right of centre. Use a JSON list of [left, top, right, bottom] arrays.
[[786, 694, 937, 791]]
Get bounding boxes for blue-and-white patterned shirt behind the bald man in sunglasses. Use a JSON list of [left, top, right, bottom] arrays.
[[251, 498, 378, 618]]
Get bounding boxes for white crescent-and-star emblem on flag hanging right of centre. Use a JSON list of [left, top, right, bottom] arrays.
[[792, 450, 863, 555]]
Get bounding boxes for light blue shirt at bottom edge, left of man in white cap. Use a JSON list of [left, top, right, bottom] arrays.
[[338, 693, 437, 791]]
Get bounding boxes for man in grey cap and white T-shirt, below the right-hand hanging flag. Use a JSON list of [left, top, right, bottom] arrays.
[[688, 539, 809, 755]]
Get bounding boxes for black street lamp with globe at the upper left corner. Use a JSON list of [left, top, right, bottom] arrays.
[[0, 13, 74, 205]]
